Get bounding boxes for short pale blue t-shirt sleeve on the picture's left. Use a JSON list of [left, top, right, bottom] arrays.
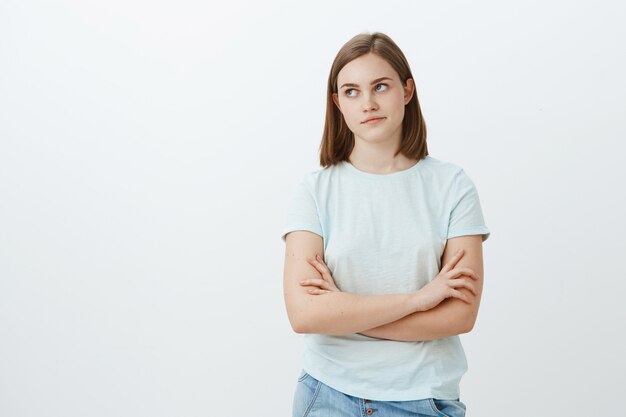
[[281, 176, 324, 242]]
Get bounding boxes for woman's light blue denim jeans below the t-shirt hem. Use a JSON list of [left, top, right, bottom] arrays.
[[293, 370, 465, 417]]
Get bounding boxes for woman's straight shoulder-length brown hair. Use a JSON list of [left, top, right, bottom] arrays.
[[320, 32, 428, 167]]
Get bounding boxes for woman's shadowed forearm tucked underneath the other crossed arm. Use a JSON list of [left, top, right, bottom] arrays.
[[359, 292, 469, 342]]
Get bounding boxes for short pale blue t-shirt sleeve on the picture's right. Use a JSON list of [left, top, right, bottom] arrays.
[[447, 169, 491, 242]]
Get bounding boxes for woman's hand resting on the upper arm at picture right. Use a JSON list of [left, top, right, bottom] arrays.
[[416, 249, 479, 311]]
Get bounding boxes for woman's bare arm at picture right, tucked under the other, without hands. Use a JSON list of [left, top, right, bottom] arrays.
[[360, 235, 483, 341]]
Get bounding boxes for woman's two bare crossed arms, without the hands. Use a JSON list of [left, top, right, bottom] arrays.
[[283, 231, 483, 341]]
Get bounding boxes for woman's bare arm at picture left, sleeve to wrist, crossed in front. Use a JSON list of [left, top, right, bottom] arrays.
[[283, 231, 419, 335]]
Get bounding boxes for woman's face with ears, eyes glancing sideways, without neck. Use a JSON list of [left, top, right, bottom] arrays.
[[333, 53, 414, 143]]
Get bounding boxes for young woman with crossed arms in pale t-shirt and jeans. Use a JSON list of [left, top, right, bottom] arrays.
[[282, 32, 490, 417]]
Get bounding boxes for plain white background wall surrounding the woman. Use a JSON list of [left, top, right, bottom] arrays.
[[0, 0, 626, 417]]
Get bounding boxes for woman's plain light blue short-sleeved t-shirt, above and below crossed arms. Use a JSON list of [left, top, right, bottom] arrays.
[[282, 156, 490, 401]]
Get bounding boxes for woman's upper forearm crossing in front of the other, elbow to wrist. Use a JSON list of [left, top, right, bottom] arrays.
[[297, 291, 419, 335]]
